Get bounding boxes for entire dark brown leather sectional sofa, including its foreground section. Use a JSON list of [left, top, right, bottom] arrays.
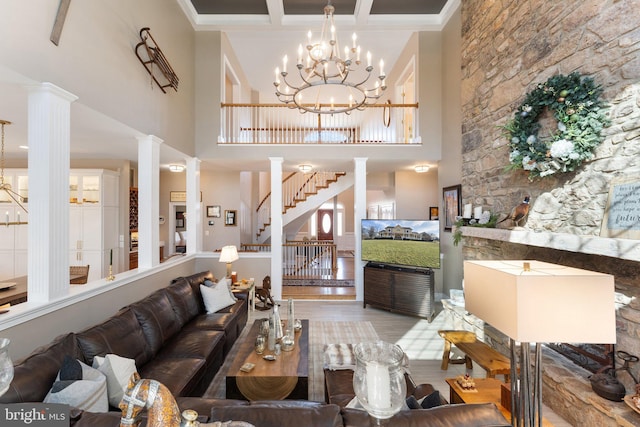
[[0, 272, 510, 427]]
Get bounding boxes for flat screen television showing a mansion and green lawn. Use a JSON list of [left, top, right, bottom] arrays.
[[361, 219, 440, 268]]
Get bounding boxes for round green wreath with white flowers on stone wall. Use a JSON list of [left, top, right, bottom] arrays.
[[504, 72, 609, 180]]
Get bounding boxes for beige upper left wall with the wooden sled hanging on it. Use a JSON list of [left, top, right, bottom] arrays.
[[0, 0, 195, 154]]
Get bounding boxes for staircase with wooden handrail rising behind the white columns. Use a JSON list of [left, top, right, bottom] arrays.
[[256, 171, 354, 243]]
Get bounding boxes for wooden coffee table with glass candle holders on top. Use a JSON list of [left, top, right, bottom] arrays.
[[226, 319, 309, 400]]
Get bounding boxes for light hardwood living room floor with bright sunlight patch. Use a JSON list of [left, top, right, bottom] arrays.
[[248, 297, 571, 427]]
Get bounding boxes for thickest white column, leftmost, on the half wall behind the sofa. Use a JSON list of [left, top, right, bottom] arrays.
[[27, 83, 78, 302]]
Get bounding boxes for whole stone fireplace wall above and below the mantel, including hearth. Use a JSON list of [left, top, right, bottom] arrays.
[[461, 0, 640, 426]]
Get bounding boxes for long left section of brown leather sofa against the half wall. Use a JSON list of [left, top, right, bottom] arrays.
[[0, 272, 248, 403]]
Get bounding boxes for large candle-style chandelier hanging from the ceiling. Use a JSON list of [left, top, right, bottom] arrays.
[[273, 0, 387, 114]]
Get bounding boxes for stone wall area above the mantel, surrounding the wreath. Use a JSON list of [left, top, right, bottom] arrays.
[[462, 0, 640, 235]]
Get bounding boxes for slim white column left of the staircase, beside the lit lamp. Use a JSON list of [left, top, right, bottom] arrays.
[[269, 157, 283, 300]]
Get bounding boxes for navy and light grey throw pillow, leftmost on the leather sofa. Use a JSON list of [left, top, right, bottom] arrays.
[[43, 356, 109, 412]]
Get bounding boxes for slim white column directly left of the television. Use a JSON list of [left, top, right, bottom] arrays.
[[353, 157, 367, 301]]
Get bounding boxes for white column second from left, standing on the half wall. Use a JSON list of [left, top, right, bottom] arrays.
[[138, 135, 163, 269]]
